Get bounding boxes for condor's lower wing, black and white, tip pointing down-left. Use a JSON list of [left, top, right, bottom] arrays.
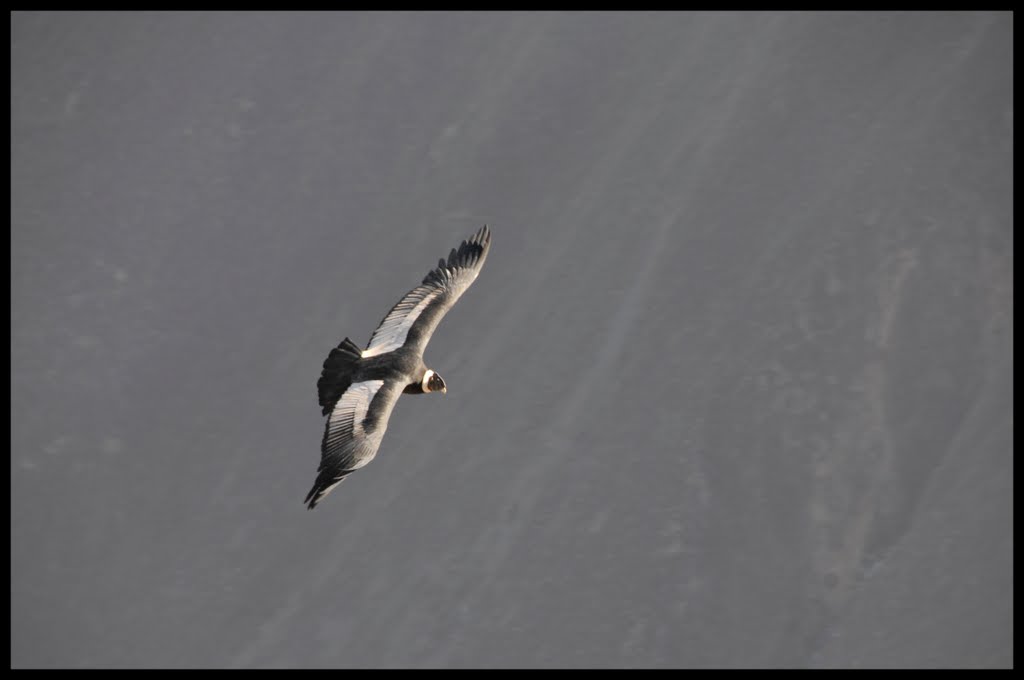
[[305, 380, 403, 510]]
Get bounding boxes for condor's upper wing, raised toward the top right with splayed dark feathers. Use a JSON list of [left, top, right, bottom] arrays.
[[362, 225, 490, 357]]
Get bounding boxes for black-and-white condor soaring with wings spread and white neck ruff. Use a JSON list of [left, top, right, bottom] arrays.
[[305, 225, 490, 510]]
